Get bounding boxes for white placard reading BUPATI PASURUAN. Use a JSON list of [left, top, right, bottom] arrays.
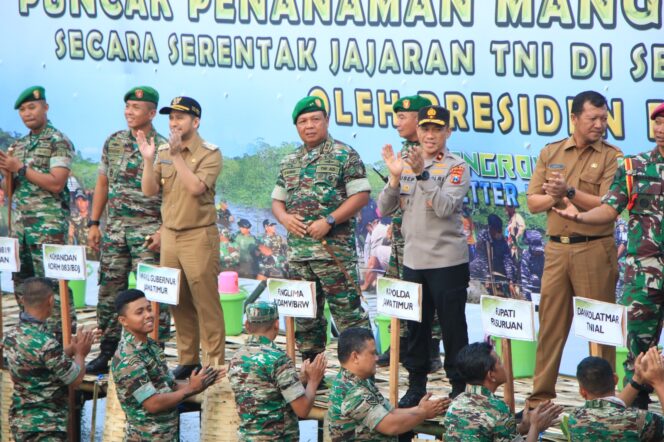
[[480, 295, 535, 341]]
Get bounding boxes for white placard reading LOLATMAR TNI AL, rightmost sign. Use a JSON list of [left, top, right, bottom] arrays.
[[574, 296, 627, 347]]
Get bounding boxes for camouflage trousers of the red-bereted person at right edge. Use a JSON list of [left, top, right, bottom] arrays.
[[620, 274, 664, 383]]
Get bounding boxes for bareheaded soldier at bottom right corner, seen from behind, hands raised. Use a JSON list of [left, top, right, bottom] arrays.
[[566, 347, 664, 442]]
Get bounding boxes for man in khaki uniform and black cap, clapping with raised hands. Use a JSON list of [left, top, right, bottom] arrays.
[[138, 97, 225, 379]]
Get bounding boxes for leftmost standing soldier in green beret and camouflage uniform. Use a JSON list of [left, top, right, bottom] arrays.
[[0, 86, 76, 339]]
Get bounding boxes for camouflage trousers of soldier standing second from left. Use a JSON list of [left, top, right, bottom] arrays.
[[97, 220, 171, 346]]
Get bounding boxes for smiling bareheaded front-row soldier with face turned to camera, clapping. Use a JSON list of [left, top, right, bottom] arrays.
[[111, 289, 220, 442]]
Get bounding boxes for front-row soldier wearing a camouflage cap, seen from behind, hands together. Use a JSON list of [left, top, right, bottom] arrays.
[[228, 301, 327, 442]]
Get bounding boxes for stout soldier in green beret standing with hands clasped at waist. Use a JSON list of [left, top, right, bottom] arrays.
[[272, 97, 371, 359]]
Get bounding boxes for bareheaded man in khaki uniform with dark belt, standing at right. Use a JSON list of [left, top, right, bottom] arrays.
[[528, 91, 622, 407]]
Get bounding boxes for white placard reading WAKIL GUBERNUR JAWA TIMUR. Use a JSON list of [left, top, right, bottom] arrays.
[[136, 262, 180, 305]]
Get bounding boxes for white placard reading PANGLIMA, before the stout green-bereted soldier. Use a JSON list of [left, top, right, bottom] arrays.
[[267, 278, 317, 318]]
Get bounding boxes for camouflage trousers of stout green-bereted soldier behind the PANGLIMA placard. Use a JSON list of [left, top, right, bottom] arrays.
[[289, 260, 371, 353]]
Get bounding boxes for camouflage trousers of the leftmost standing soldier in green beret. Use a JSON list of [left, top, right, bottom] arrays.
[[12, 232, 76, 341]]
